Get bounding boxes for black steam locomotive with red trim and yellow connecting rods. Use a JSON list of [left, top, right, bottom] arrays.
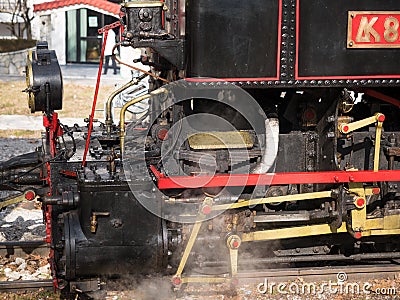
[[0, 0, 400, 293]]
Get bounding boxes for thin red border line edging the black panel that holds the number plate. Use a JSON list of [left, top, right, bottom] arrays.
[[294, 0, 400, 80]]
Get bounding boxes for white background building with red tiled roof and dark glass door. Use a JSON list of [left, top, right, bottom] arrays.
[[32, 0, 120, 64]]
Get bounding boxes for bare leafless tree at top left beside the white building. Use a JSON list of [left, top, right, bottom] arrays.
[[8, 0, 34, 40]]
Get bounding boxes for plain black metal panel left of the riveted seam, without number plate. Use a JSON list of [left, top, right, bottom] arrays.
[[186, 0, 280, 78]]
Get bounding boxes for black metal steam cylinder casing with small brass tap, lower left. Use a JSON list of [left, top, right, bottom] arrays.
[[65, 182, 167, 278]]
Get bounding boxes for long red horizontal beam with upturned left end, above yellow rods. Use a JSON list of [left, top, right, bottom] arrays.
[[150, 166, 400, 190]]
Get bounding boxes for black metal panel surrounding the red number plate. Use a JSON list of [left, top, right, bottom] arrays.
[[297, 0, 400, 79]]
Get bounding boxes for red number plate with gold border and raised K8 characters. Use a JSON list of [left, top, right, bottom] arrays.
[[347, 11, 400, 48]]
